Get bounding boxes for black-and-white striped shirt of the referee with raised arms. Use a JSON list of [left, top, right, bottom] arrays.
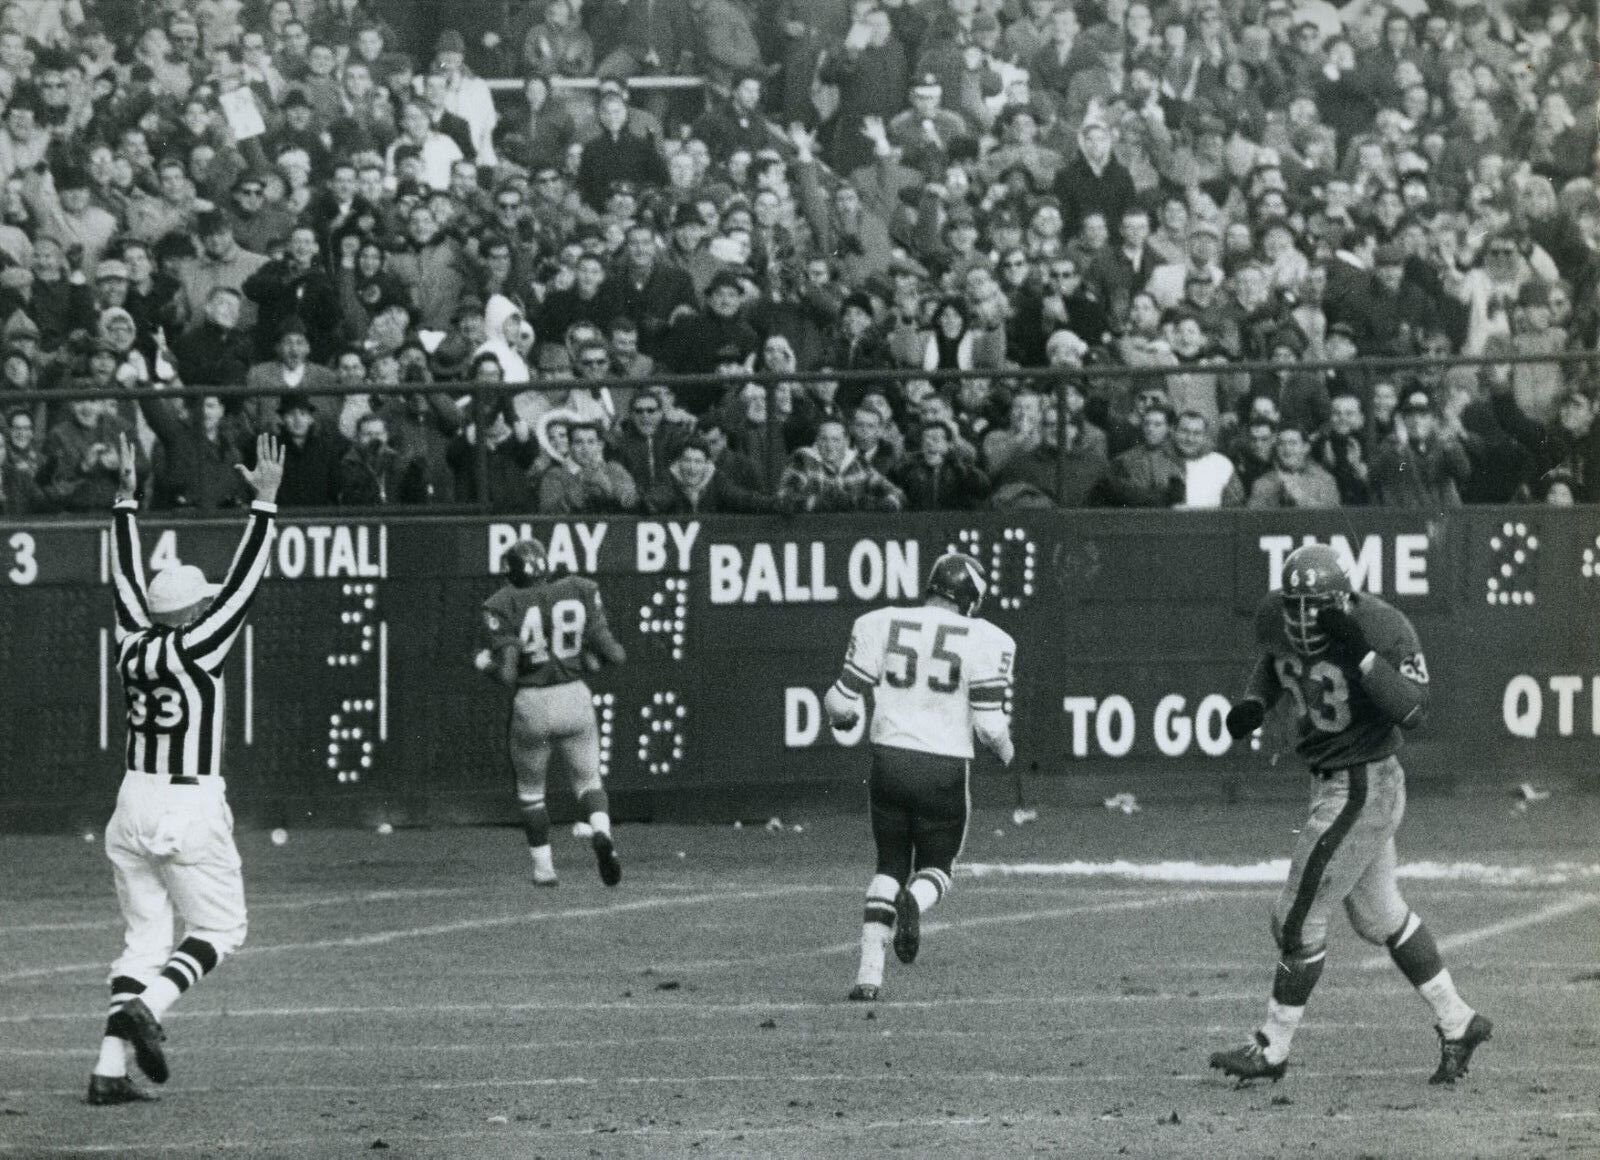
[[112, 499, 278, 778]]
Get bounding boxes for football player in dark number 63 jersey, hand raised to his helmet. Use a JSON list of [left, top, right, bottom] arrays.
[[1211, 544, 1491, 1083]]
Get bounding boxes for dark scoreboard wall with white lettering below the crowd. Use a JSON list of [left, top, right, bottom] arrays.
[[0, 509, 1600, 829]]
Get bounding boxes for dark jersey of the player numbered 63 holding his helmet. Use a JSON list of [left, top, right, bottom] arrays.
[[1251, 594, 1427, 770]]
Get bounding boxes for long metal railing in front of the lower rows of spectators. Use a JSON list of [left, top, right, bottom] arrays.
[[0, 350, 1600, 512]]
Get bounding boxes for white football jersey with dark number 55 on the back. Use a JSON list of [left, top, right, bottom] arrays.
[[845, 606, 1016, 760]]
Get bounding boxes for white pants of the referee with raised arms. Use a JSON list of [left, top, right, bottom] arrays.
[[106, 771, 248, 984]]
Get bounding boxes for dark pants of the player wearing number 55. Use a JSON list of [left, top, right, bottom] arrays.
[[867, 746, 971, 883]]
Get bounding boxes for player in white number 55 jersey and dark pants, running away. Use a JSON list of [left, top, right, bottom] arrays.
[[824, 554, 1016, 1002]]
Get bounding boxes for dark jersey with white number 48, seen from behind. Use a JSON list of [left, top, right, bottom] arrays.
[[483, 576, 616, 688]]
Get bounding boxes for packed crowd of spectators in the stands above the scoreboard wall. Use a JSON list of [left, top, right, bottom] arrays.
[[0, 0, 1600, 517]]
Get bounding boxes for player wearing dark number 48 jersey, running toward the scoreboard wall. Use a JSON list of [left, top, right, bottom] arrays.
[[475, 539, 627, 886]]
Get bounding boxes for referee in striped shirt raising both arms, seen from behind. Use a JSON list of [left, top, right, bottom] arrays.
[[88, 435, 283, 1104]]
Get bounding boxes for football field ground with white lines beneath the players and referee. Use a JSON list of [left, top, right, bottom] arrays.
[[0, 789, 1600, 1160]]
